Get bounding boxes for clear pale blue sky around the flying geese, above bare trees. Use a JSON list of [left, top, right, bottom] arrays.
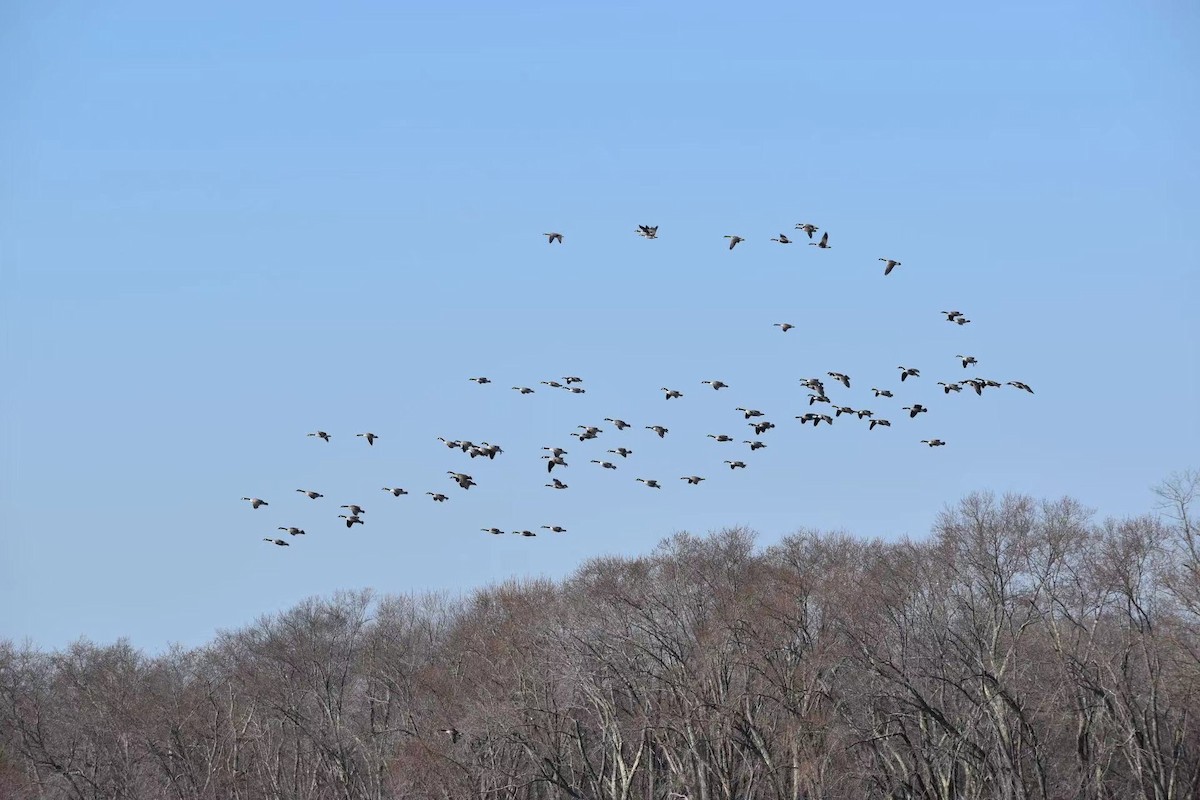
[[0, 0, 1200, 651]]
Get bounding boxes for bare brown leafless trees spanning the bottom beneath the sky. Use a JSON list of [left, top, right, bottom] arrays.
[[0, 473, 1200, 800]]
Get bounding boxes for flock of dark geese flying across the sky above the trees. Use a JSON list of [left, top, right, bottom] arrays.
[[241, 222, 1033, 547]]
